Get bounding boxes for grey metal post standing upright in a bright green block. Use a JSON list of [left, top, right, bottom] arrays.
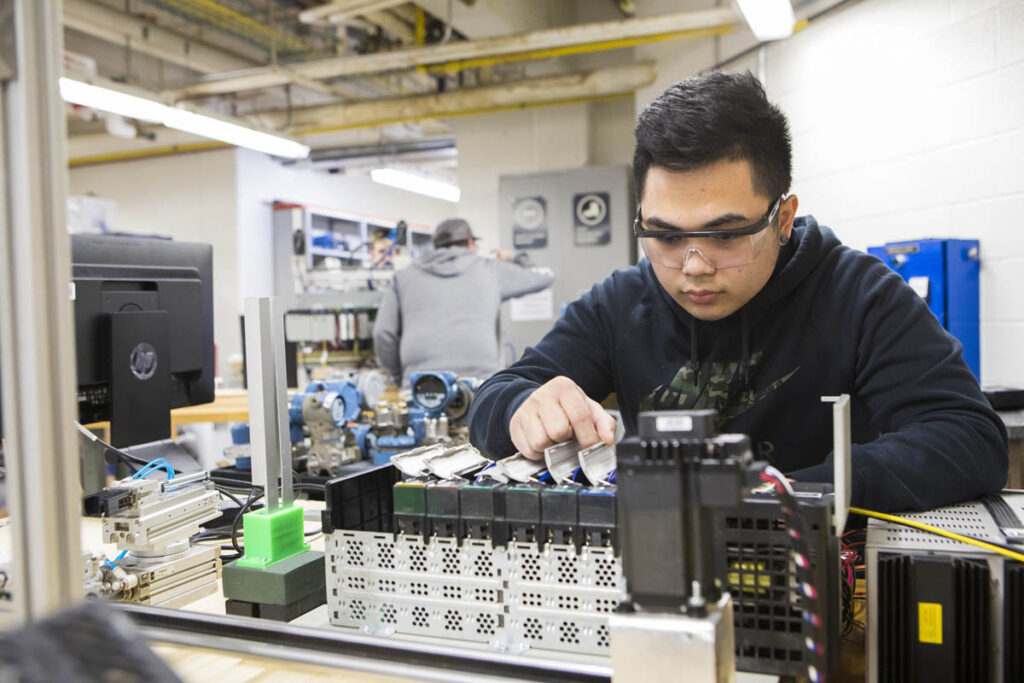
[[246, 297, 293, 512]]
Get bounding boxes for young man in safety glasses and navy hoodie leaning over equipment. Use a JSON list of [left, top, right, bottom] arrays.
[[470, 72, 1007, 511]]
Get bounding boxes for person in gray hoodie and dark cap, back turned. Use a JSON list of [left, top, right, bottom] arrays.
[[374, 218, 552, 386]]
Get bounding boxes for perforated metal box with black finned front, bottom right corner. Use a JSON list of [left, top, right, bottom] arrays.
[[865, 494, 1024, 682]]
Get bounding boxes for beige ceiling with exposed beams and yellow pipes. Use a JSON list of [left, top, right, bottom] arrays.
[[63, 0, 739, 165]]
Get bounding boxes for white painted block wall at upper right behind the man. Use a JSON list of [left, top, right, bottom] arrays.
[[766, 0, 1024, 384]]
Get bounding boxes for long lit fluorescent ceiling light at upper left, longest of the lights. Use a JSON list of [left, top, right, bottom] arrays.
[[60, 78, 309, 159]]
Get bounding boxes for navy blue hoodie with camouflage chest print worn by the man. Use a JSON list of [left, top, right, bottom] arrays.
[[470, 216, 1008, 511]]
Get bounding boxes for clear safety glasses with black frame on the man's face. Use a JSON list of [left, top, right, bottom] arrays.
[[633, 197, 782, 268]]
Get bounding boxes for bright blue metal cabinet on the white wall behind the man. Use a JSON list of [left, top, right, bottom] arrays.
[[867, 240, 981, 380]]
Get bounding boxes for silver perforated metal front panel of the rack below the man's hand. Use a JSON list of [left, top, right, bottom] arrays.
[[327, 530, 625, 654]]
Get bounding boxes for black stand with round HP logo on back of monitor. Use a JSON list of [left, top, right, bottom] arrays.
[[111, 311, 171, 447]]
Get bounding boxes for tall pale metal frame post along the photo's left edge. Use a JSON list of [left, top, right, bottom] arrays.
[[0, 0, 82, 621]]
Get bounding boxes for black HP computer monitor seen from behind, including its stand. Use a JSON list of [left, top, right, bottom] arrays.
[[72, 234, 214, 446]]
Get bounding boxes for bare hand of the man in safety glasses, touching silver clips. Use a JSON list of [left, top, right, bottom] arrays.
[[509, 377, 615, 460]]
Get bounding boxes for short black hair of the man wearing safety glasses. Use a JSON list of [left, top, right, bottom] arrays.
[[633, 71, 793, 202]]
